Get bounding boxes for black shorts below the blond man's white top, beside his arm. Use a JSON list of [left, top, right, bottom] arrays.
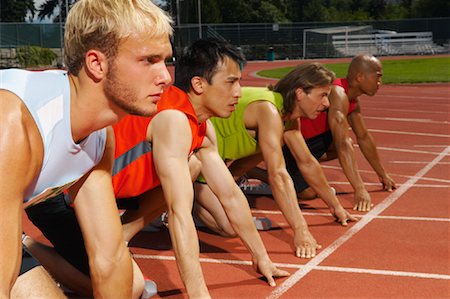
[[25, 194, 89, 276]]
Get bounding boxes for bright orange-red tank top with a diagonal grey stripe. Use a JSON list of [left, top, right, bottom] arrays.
[[113, 86, 206, 198]]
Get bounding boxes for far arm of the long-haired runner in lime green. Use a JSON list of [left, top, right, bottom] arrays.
[[283, 120, 356, 226]]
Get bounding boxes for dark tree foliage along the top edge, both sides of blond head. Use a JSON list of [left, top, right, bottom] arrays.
[[8, 0, 444, 25]]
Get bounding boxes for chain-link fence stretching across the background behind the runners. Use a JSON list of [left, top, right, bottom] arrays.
[[0, 17, 450, 67]]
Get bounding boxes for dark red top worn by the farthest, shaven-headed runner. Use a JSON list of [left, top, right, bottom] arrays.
[[300, 78, 357, 140]]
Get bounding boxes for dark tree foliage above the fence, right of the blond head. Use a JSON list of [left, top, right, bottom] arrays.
[[166, 0, 442, 24]]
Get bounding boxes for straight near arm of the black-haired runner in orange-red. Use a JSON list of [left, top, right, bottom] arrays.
[[148, 110, 209, 298]]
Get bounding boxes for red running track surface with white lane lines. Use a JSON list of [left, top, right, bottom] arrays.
[[27, 55, 450, 298]]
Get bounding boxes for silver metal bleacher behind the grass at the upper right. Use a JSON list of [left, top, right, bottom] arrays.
[[332, 32, 448, 56]]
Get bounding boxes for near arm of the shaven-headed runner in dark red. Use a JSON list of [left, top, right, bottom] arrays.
[[328, 86, 371, 211]]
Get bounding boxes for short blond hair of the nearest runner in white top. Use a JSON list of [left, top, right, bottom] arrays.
[[64, 0, 173, 75]]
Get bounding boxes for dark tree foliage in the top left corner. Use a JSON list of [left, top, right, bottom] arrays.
[[0, 0, 36, 22]]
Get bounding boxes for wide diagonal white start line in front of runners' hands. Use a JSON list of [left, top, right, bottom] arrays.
[[268, 146, 450, 299]]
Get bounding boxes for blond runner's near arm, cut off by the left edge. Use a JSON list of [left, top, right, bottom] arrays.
[[0, 90, 43, 298]]
